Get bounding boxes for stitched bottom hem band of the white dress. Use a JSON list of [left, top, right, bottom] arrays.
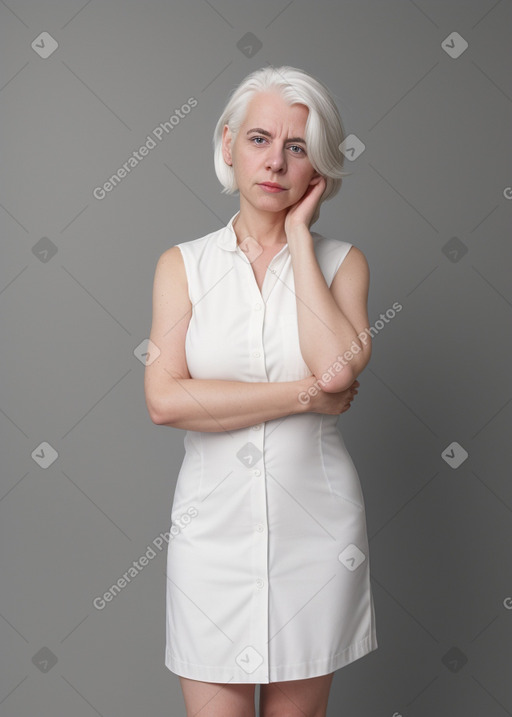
[[165, 630, 378, 684]]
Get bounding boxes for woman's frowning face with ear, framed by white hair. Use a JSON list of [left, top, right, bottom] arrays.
[[222, 91, 319, 211]]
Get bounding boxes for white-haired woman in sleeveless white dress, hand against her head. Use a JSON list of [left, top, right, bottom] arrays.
[[145, 67, 377, 717]]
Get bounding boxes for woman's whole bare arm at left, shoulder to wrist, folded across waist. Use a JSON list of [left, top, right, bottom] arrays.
[[144, 247, 312, 431]]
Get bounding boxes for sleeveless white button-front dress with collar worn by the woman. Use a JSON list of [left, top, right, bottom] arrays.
[[165, 212, 378, 684]]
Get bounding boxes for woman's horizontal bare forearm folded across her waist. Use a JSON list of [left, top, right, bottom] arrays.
[[155, 378, 306, 432]]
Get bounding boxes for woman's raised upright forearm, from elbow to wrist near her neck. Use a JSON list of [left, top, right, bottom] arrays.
[[288, 227, 369, 391]]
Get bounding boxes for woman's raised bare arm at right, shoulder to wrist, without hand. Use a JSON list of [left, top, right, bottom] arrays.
[[288, 226, 371, 392]]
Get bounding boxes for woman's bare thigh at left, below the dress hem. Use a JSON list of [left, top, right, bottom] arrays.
[[180, 677, 255, 717]]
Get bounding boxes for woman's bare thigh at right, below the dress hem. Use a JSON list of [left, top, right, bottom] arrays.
[[260, 672, 334, 717]]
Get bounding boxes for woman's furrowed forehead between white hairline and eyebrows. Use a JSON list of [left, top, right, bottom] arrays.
[[243, 92, 309, 131]]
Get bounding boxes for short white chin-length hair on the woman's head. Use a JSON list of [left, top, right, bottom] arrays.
[[213, 65, 350, 224]]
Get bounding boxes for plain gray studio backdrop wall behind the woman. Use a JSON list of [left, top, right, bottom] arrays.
[[0, 0, 512, 717]]
